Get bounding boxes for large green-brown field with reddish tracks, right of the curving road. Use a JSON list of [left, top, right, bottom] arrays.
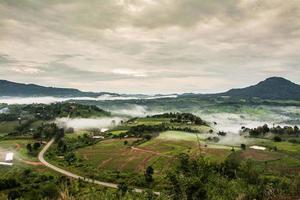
[[72, 139, 190, 174]]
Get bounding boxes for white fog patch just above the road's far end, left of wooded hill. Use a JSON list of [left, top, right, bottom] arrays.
[[55, 117, 124, 130]]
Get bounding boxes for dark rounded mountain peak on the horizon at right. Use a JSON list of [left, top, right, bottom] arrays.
[[218, 77, 300, 100]]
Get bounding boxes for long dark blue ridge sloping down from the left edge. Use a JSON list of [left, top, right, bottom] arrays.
[[0, 80, 117, 97]]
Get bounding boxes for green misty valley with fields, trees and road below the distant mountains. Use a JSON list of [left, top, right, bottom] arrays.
[[0, 77, 300, 199]]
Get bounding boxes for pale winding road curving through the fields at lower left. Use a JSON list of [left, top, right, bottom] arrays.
[[38, 139, 146, 195]]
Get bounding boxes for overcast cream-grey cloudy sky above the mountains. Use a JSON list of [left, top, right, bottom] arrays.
[[0, 0, 300, 94]]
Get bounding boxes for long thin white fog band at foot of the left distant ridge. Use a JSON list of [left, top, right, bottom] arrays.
[[0, 94, 177, 105]]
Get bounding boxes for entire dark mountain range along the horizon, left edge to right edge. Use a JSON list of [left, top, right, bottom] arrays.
[[0, 77, 300, 100]]
